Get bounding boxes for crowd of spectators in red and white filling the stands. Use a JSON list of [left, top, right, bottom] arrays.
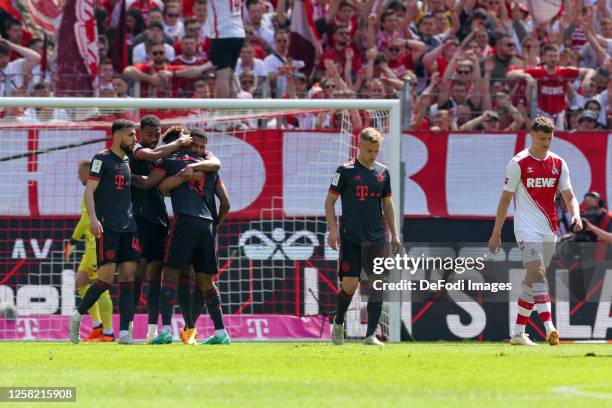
[[0, 0, 612, 131]]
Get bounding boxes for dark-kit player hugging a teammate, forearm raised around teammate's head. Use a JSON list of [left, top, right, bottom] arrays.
[[130, 115, 191, 343]]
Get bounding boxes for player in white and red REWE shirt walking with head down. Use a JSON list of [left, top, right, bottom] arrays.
[[489, 116, 582, 346]]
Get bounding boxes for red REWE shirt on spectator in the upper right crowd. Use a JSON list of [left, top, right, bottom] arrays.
[[525, 66, 580, 114]]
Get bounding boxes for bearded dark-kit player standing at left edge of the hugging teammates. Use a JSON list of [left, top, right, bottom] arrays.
[[69, 119, 140, 344]]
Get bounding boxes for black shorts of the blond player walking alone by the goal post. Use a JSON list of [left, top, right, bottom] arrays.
[[338, 239, 383, 280]]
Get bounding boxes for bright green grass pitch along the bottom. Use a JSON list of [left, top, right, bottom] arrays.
[[0, 343, 612, 408]]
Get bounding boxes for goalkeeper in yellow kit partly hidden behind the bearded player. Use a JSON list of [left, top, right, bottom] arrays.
[[64, 160, 115, 342]]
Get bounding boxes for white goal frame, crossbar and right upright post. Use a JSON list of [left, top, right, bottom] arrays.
[[0, 97, 403, 342]]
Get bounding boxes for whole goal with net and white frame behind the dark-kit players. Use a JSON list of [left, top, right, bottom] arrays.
[[0, 98, 401, 341]]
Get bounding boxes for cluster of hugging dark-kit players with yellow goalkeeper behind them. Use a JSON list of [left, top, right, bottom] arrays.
[[65, 115, 231, 344]]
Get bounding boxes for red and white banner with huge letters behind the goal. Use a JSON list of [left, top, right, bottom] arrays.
[[0, 128, 612, 219]]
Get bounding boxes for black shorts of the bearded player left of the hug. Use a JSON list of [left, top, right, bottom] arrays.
[[96, 229, 141, 268]]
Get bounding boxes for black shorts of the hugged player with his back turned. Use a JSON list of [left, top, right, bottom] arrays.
[[164, 214, 218, 275]]
